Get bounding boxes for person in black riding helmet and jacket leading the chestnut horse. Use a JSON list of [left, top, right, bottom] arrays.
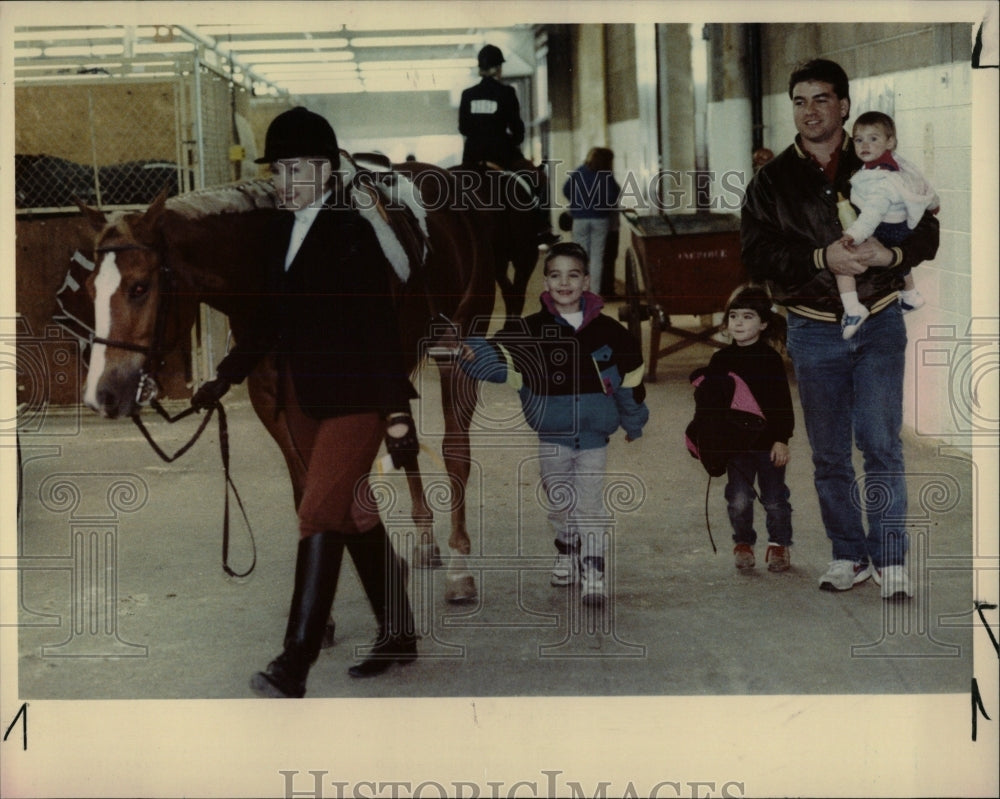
[[191, 107, 418, 697]]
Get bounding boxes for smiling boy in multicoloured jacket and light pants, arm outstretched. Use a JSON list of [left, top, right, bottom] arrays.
[[459, 242, 649, 605]]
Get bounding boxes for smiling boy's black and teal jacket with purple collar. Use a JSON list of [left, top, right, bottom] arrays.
[[459, 292, 649, 449]]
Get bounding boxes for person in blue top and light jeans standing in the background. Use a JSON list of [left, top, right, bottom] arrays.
[[563, 147, 622, 293]]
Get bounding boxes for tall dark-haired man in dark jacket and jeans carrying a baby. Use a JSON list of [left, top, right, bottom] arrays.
[[741, 59, 939, 599]]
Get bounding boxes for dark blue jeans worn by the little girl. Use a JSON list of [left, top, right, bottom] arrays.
[[726, 451, 792, 547]]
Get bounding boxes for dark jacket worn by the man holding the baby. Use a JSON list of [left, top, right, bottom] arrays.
[[740, 131, 939, 322]]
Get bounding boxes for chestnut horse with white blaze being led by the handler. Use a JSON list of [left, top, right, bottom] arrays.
[[81, 162, 495, 602]]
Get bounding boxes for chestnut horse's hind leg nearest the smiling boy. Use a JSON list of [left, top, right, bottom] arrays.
[[439, 364, 479, 602]]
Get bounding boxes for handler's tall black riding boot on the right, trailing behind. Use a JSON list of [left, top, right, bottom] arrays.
[[347, 524, 417, 677]]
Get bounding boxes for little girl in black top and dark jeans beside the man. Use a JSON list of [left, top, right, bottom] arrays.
[[707, 286, 795, 572]]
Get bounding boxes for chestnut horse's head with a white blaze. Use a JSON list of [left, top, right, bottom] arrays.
[[80, 193, 168, 418]]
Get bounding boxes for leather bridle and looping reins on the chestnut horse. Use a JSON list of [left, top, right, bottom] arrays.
[[90, 243, 257, 577]]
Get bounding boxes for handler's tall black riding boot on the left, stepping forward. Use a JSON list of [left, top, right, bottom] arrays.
[[250, 532, 344, 697]]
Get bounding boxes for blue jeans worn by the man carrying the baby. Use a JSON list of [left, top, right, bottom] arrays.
[[788, 303, 908, 569]]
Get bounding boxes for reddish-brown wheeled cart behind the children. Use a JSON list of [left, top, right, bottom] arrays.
[[618, 209, 747, 381]]
